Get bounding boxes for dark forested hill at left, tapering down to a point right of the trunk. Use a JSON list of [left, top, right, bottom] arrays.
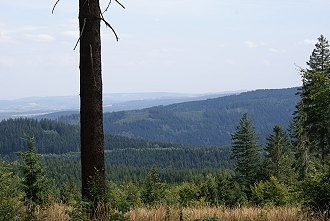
[[0, 118, 208, 154]]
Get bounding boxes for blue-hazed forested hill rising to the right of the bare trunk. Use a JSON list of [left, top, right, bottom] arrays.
[[104, 88, 298, 145]]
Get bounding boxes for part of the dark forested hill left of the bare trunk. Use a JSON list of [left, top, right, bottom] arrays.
[[0, 118, 79, 154]]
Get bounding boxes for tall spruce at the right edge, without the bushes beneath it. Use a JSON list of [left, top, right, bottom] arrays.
[[295, 35, 330, 163]]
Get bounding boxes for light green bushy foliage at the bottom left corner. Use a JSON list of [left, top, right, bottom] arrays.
[[0, 160, 24, 220]]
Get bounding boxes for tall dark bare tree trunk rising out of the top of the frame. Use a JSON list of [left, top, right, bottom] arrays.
[[79, 0, 105, 202]]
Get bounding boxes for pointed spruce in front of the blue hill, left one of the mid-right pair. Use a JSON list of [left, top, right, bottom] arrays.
[[231, 114, 260, 196]]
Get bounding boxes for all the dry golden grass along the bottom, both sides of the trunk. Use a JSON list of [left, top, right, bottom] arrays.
[[39, 204, 323, 221]]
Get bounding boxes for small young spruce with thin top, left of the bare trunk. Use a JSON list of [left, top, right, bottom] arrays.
[[19, 137, 50, 206]]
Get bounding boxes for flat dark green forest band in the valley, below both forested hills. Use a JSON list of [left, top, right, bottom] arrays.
[[43, 147, 232, 186]]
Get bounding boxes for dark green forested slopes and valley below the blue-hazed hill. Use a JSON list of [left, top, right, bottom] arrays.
[[0, 119, 231, 185]]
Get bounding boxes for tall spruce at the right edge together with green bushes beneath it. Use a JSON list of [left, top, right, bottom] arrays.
[[294, 35, 330, 218]]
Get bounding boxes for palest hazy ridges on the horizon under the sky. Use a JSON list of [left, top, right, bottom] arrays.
[[0, 92, 238, 120]]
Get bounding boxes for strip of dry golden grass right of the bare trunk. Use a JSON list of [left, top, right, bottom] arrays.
[[127, 207, 316, 221]]
